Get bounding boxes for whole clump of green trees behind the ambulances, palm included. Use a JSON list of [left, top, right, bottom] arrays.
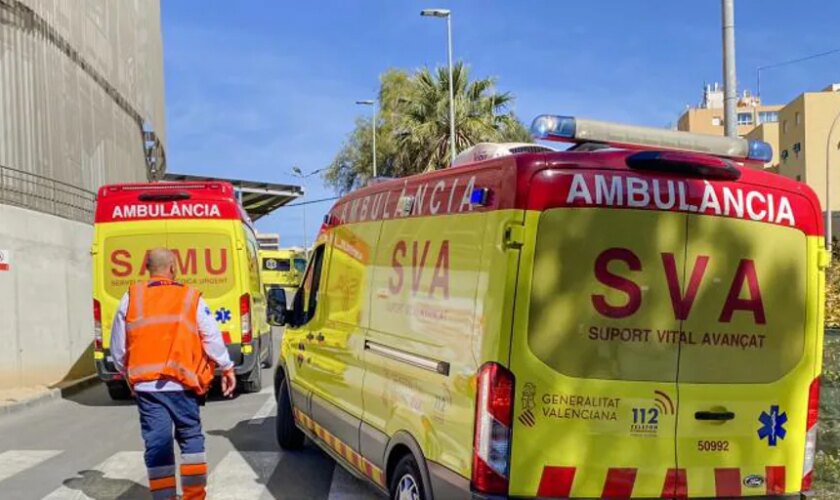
[[324, 63, 532, 193]]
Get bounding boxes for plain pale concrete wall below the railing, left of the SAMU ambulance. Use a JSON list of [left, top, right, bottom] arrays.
[[0, 204, 94, 389]]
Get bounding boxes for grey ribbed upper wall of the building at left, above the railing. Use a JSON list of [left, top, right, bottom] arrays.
[[0, 0, 166, 191]]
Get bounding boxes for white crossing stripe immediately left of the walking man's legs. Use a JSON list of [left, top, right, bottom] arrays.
[[44, 451, 148, 500]]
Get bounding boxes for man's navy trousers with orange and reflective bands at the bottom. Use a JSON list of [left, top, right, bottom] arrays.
[[136, 391, 207, 499]]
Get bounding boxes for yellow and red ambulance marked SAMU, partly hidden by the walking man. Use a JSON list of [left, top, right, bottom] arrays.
[[91, 182, 273, 399]]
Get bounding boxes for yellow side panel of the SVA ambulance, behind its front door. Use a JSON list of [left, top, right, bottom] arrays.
[[362, 159, 521, 494]]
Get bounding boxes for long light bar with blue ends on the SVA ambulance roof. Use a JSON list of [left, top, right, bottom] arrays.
[[531, 115, 773, 163]]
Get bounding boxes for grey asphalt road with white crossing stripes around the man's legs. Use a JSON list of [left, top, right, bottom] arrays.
[[0, 370, 378, 500]]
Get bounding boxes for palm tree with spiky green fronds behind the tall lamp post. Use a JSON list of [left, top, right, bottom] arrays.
[[394, 63, 523, 171]]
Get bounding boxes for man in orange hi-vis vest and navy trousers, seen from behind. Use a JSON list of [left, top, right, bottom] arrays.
[[111, 248, 236, 500]]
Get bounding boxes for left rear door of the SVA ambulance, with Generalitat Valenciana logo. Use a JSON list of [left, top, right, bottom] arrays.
[[510, 170, 687, 498]]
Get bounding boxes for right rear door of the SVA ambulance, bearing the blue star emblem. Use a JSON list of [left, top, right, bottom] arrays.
[[677, 182, 822, 498]]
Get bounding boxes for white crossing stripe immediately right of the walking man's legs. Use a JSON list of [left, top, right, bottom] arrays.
[[207, 451, 282, 500]]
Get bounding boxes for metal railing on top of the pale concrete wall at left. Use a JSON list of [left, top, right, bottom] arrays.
[[0, 165, 96, 224]]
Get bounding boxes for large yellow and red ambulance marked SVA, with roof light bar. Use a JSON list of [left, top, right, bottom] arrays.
[[269, 115, 829, 499]]
